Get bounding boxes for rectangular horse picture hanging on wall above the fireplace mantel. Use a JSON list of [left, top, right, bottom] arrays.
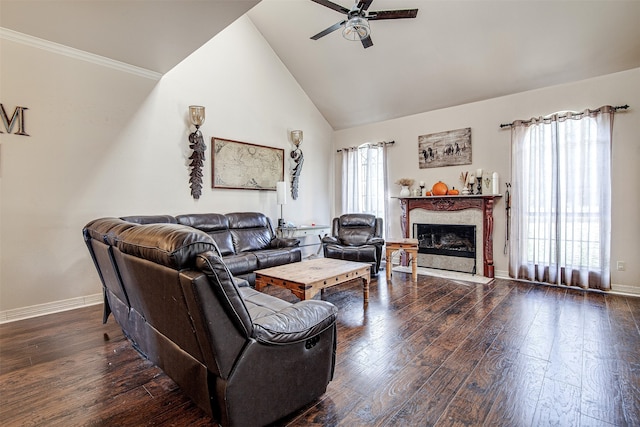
[[418, 128, 471, 169]]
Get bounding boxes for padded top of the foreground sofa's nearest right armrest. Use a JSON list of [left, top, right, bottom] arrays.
[[253, 300, 338, 344]]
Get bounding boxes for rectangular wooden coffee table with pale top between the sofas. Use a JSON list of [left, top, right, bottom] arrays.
[[255, 258, 371, 302]]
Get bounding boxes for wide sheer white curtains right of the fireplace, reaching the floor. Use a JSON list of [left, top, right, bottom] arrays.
[[509, 106, 615, 290]]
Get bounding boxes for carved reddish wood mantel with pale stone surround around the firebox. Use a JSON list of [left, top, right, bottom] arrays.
[[397, 195, 502, 278]]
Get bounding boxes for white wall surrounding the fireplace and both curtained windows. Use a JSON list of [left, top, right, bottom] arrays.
[[334, 69, 640, 293]]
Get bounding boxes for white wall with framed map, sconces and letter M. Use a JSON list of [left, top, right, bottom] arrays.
[[0, 17, 333, 321]]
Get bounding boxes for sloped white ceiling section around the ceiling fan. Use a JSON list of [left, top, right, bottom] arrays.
[[249, 0, 640, 129]]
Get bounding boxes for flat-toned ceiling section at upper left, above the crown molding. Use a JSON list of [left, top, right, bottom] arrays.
[[0, 0, 260, 74]]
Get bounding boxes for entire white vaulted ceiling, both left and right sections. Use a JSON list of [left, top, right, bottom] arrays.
[[0, 0, 640, 129]]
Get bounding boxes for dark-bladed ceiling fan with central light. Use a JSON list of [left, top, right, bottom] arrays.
[[311, 0, 418, 49]]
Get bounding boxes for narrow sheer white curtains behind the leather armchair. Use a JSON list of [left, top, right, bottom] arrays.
[[342, 143, 388, 237]]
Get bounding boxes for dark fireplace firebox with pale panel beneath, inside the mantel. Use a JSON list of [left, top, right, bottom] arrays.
[[413, 223, 476, 274]]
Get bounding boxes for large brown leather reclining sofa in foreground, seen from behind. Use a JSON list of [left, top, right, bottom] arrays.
[[83, 218, 337, 426]]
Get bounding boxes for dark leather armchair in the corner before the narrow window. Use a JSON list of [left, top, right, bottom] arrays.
[[322, 214, 384, 274]]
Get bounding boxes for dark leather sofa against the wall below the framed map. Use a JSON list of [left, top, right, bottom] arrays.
[[120, 212, 302, 286]]
